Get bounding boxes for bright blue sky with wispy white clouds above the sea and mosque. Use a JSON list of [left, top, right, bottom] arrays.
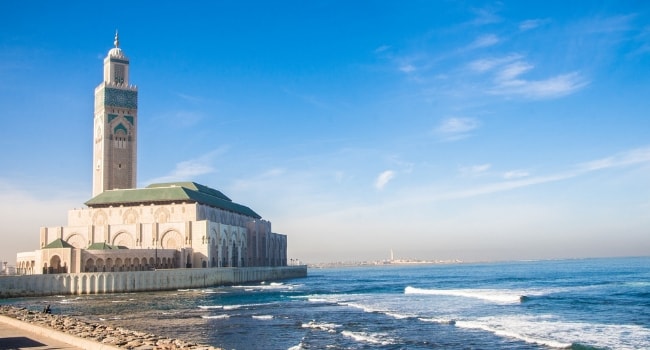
[[0, 1, 650, 262]]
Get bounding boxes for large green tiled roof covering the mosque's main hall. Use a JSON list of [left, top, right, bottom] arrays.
[[86, 182, 262, 219]]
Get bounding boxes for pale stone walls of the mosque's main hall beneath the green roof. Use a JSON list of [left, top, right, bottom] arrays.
[[26, 203, 286, 274]]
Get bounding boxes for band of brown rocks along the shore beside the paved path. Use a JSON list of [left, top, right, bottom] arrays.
[[0, 305, 219, 350]]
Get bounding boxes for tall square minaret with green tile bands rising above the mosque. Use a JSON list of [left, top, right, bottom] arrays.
[[93, 31, 138, 197]]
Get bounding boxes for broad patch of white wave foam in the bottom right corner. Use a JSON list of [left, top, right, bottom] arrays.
[[456, 315, 650, 349]]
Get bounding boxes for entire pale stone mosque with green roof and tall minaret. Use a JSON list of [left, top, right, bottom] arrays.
[[16, 33, 287, 275]]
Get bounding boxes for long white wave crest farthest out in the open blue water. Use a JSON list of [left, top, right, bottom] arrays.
[[404, 286, 528, 304]]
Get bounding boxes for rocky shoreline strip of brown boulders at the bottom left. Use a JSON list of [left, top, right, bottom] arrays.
[[0, 305, 220, 350]]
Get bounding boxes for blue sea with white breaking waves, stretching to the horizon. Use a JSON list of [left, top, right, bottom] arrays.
[[0, 257, 650, 350]]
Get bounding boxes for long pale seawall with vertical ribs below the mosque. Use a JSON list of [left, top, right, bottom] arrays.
[[0, 265, 307, 298]]
